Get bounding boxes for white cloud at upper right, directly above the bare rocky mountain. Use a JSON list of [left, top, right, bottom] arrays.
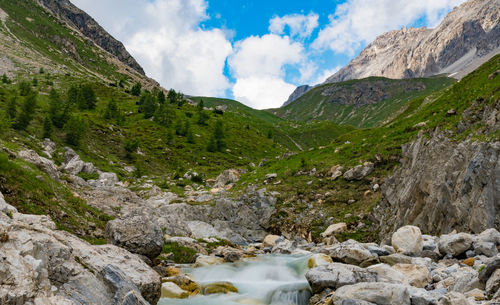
[[312, 0, 465, 56]]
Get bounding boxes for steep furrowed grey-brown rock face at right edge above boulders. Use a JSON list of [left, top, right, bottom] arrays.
[[374, 129, 500, 240]]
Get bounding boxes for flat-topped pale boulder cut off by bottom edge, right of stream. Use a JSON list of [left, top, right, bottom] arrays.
[[333, 283, 411, 305]]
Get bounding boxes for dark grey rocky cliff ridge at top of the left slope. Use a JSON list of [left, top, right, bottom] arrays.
[[37, 0, 145, 75]]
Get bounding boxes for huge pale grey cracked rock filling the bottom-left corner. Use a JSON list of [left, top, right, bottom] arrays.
[[0, 192, 161, 305]]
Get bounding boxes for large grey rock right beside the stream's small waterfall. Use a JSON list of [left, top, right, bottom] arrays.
[[306, 263, 377, 293]]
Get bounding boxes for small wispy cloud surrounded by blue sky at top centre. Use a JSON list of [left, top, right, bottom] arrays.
[[269, 13, 319, 38]]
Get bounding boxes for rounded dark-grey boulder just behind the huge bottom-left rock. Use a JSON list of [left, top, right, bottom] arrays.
[[106, 215, 165, 259]]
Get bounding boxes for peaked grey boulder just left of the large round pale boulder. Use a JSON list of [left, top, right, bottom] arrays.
[[323, 240, 377, 265]]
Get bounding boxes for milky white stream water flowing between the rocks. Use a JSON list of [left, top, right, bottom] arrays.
[[158, 255, 311, 305]]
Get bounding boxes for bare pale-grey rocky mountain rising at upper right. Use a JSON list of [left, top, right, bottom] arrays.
[[325, 0, 500, 83]]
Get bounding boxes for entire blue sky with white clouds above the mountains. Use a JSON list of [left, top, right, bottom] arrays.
[[71, 0, 465, 109]]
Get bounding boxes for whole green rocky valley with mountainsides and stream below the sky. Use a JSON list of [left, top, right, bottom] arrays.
[[0, 0, 500, 305]]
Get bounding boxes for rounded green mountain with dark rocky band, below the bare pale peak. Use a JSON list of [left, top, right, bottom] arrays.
[[269, 77, 453, 128]]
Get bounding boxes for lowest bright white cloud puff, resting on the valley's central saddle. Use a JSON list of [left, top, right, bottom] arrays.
[[233, 76, 296, 109]]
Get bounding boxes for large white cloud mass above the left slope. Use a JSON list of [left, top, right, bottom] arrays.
[[74, 0, 232, 96]]
